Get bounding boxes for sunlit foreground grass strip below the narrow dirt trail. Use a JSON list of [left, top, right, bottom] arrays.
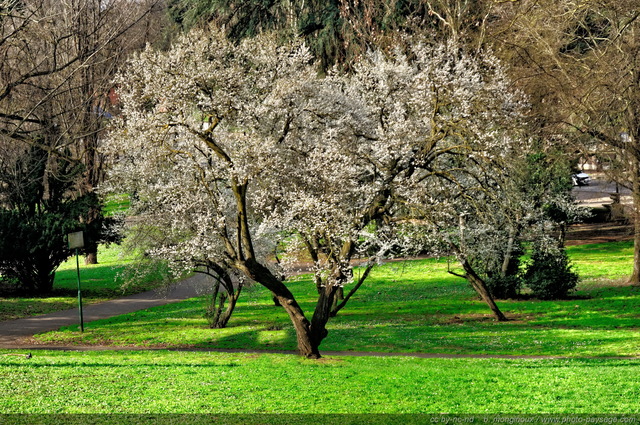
[[0, 351, 640, 412]]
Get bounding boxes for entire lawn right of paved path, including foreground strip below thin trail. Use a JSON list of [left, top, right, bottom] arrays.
[[0, 243, 640, 416]]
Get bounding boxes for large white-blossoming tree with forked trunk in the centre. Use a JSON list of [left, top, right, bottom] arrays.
[[106, 26, 521, 358]]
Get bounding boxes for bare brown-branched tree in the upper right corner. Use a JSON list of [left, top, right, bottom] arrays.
[[488, 0, 640, 284]]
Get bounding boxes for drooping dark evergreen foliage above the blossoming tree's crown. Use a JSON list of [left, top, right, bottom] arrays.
[[168, 0, 434, 70]]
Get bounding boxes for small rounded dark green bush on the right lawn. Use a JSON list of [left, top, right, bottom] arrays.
[[524, 248, 579, 300]]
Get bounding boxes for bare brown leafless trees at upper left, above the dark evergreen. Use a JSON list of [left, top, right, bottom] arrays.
[[0, 0, 164, 262]]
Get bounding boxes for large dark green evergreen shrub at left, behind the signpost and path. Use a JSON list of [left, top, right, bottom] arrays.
[[0, 145, 118, 294]]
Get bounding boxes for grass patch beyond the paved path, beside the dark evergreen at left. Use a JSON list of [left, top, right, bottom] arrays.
[[0, 245, 168, 321]]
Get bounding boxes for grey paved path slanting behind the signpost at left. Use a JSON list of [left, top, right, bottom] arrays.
[[0, 274, 207, 348]]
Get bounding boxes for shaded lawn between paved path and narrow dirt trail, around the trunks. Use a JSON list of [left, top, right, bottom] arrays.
[[36, 242, 640, 357]]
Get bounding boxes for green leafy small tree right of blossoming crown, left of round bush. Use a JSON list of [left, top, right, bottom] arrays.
[[465, 151, 579, 299]]
